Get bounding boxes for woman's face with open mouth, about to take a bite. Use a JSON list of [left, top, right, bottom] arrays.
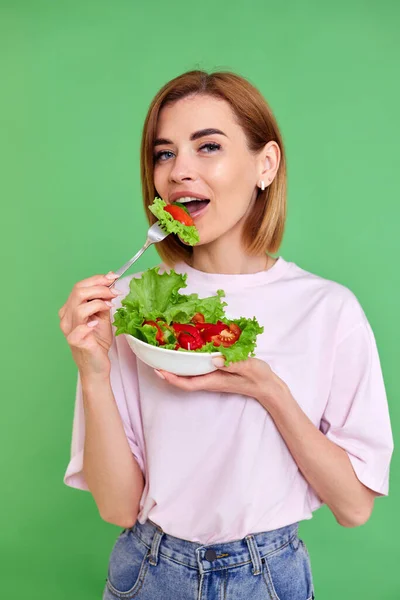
[[154, 95, 267, 245]]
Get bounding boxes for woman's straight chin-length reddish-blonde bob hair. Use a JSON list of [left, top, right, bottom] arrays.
[[140, 70, 286, 266]]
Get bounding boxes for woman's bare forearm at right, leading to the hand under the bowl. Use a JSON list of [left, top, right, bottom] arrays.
[[257, 380, 376, 527]]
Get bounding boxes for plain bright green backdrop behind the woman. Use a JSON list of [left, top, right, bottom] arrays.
[[0, 0, 400, 600]]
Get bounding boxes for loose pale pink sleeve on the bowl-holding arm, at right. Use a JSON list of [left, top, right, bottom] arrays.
[[320, 318, 393, 495]]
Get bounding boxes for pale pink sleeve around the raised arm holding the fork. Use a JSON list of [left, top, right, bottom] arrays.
[[64, 336, 145, 491]]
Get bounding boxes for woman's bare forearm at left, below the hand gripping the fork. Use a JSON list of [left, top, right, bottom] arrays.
[[81, 377, 144, 528]]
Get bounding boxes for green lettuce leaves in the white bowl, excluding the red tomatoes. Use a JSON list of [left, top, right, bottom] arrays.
[[113, 267, 264, 366]]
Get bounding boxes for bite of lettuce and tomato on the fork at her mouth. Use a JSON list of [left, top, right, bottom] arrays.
[[149, 198, 200, 246]]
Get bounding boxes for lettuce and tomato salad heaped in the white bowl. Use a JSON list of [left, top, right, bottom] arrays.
[[113, 267, 264, 366]]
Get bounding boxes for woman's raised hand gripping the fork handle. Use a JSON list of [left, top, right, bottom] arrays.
[[58, 273, 123, 377]]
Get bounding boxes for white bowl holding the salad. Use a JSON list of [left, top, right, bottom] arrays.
[[123, 333, 222, 375]]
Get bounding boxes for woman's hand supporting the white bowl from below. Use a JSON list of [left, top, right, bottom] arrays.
[[155, 357, 286, 408]]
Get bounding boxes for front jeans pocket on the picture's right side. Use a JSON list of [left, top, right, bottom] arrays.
[[262, 536, 314, 600]]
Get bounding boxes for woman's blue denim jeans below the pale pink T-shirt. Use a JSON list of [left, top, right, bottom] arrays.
[[103, 520, 314, 600]]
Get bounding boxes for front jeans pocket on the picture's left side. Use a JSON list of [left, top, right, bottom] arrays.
[[107, 529, 150, 600]]
